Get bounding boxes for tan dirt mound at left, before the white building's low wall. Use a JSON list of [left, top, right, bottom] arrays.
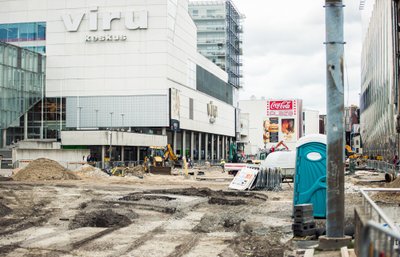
[[13, 158, 79, 181]]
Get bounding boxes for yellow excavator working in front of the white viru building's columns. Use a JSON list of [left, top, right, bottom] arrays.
[[143, 144, 182, 175]]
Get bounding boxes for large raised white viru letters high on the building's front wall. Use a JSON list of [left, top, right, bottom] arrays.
[[62, 7, 147, 32]]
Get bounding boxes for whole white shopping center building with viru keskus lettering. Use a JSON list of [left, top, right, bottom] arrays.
[[0, 0, 238, 160]]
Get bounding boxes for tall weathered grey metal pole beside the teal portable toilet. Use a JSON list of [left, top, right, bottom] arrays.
[[325, 0, 344, 238]]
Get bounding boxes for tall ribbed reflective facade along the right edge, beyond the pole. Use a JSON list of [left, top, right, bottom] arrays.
[[360, 1, 398, 160]]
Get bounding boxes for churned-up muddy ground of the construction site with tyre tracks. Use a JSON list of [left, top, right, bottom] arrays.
[[0, 165, 390, 257]]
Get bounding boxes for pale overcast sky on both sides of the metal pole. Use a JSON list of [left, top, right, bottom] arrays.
[[233, 0, 361, 113]]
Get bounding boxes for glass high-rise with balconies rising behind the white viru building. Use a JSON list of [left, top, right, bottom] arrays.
[[189, 0, 243, 88]]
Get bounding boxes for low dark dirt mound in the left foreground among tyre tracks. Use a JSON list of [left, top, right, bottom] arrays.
[[69, 209, 131, 229]]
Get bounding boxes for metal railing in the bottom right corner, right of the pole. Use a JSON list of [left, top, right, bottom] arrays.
[[356, 188, 400, 257]]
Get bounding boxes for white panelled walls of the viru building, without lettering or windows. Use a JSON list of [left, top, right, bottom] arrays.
[[0, 0, 235, 136]]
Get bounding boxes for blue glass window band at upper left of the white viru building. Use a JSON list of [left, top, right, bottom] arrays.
[[0, 22, 46, 54]]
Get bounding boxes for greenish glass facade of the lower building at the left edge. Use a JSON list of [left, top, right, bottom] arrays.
[[0, 42, 46, 144]]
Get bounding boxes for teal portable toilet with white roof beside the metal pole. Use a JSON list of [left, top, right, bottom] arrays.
[[293, 134, 326, 218]]
